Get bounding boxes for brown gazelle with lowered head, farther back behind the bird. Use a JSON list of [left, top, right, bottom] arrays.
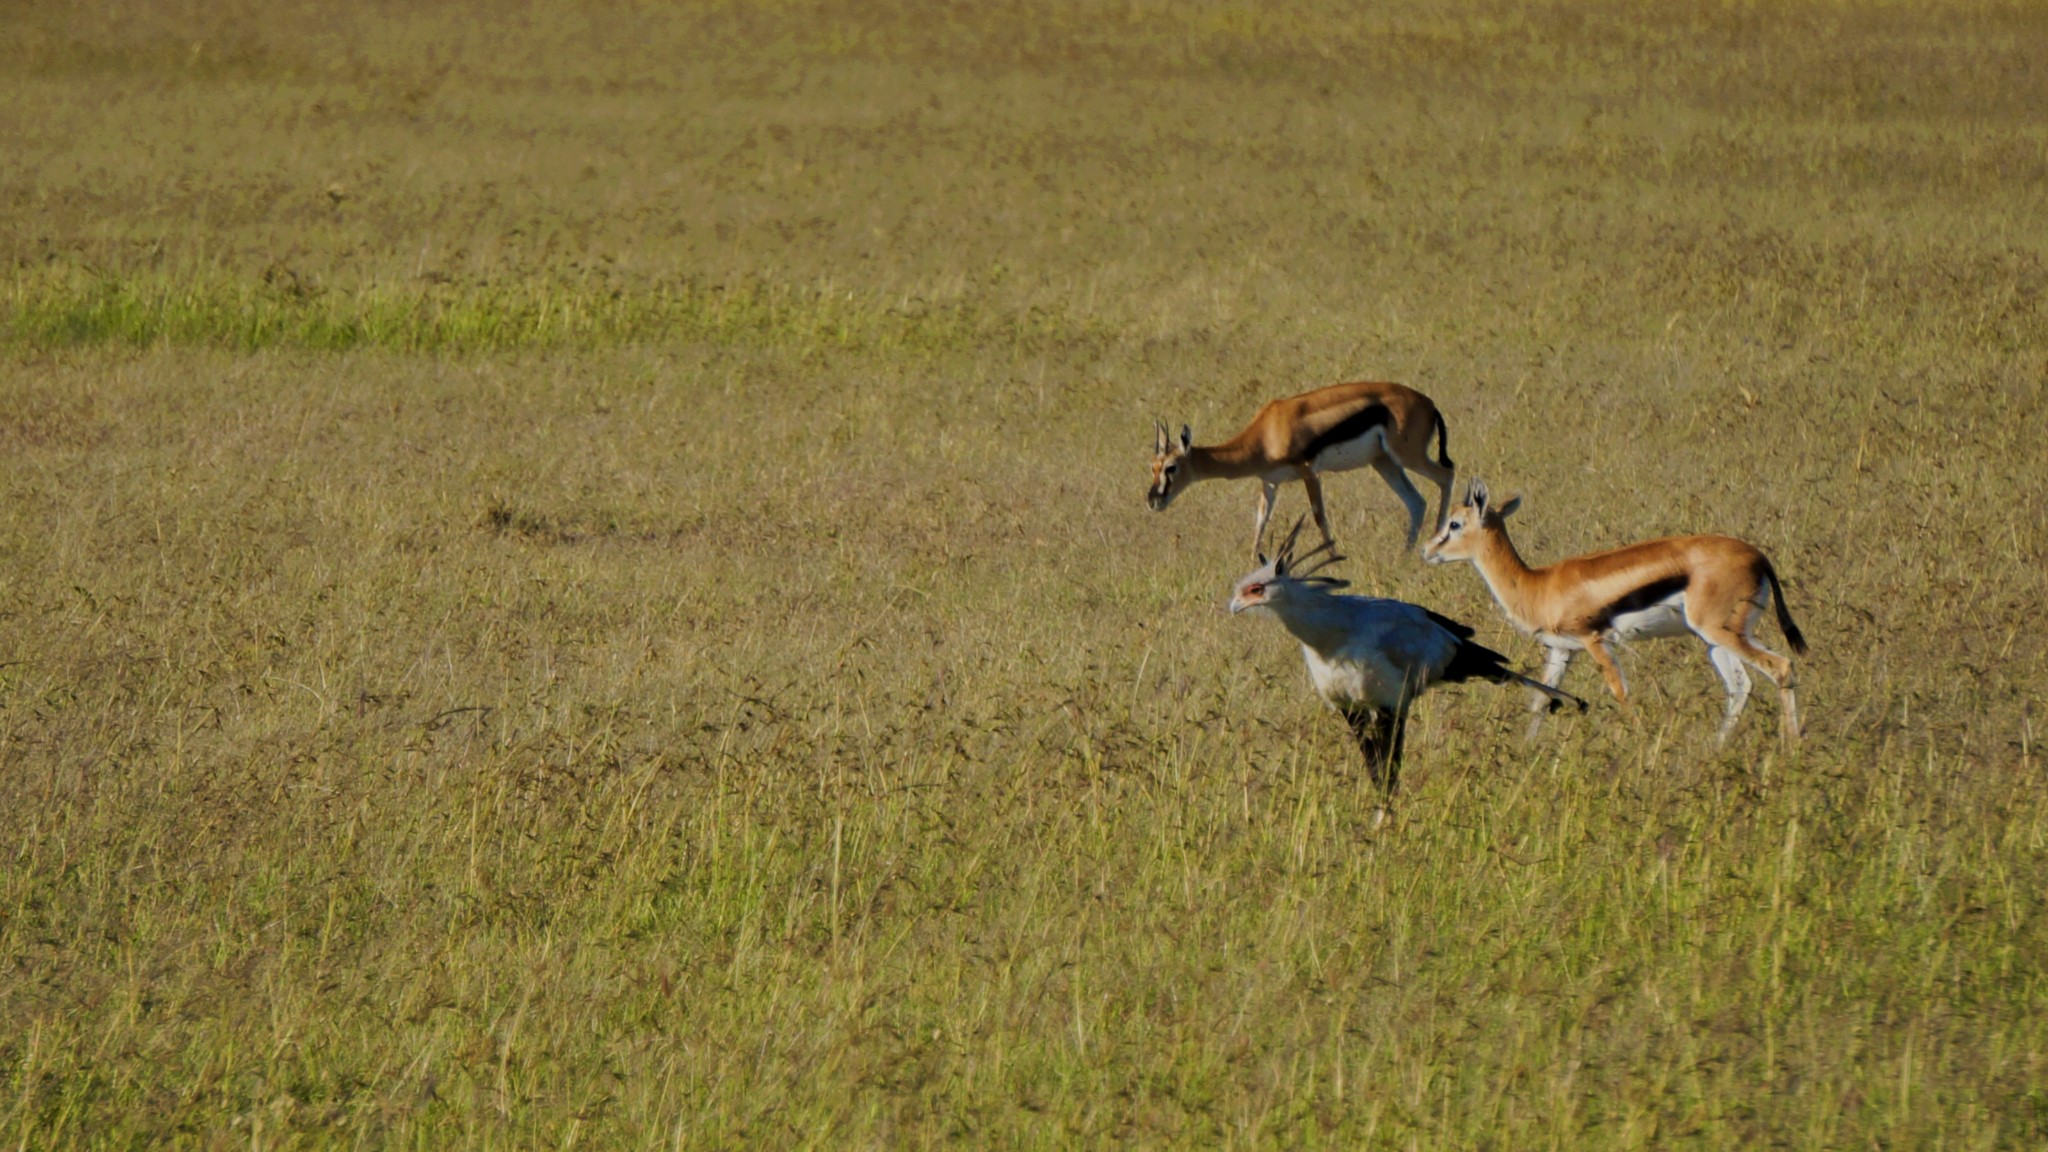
[[1145, 383, 1456, 551]]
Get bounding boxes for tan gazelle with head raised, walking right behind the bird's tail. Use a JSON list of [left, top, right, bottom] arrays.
[[1421, 480, 1806, 742]]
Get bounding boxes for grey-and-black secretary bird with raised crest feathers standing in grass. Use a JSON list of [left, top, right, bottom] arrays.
[[1231, 521, 1585, 795]]
